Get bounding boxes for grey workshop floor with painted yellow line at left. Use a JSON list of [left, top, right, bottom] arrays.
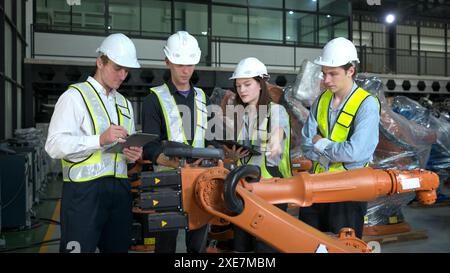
[[0, 175, 450, 253]]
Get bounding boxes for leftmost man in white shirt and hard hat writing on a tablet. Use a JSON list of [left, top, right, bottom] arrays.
[[45, 33, 142, 253]]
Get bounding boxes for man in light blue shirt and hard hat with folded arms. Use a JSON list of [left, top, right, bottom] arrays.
[[299, 37, 380, 238]]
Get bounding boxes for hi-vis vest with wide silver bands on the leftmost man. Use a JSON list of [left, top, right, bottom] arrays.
[[62, 82, 132, 182]]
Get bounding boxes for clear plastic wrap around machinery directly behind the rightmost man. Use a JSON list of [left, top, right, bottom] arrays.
[[356, 74, 436, 230]]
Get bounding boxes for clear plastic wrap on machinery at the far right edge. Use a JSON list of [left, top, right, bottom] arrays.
[[392, 96, 450, 181]]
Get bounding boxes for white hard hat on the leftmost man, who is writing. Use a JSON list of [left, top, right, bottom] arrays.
[[97, 33, 141, 68]]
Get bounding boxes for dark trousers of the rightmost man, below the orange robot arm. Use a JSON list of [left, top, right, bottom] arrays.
[[298, 202, 367, 238]]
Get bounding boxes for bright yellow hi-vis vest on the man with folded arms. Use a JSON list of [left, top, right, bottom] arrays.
[[313, 87, 378, 173]]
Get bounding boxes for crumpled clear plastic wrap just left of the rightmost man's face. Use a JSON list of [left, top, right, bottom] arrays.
[[284, 60, 322, 108]]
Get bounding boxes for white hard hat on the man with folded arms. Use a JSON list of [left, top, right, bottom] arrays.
[[314, 37, 359, 67]]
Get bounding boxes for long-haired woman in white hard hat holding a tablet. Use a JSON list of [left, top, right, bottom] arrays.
[[224, 57, 292, 252]]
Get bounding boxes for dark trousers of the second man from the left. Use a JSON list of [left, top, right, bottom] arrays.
[[155, 225, 208, 253]]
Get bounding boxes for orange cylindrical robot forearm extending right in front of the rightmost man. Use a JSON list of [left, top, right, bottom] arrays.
[[244, 168, 439, 207]]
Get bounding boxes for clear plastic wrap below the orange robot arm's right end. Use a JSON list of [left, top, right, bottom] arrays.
[[364, 192, 416, 227]]
